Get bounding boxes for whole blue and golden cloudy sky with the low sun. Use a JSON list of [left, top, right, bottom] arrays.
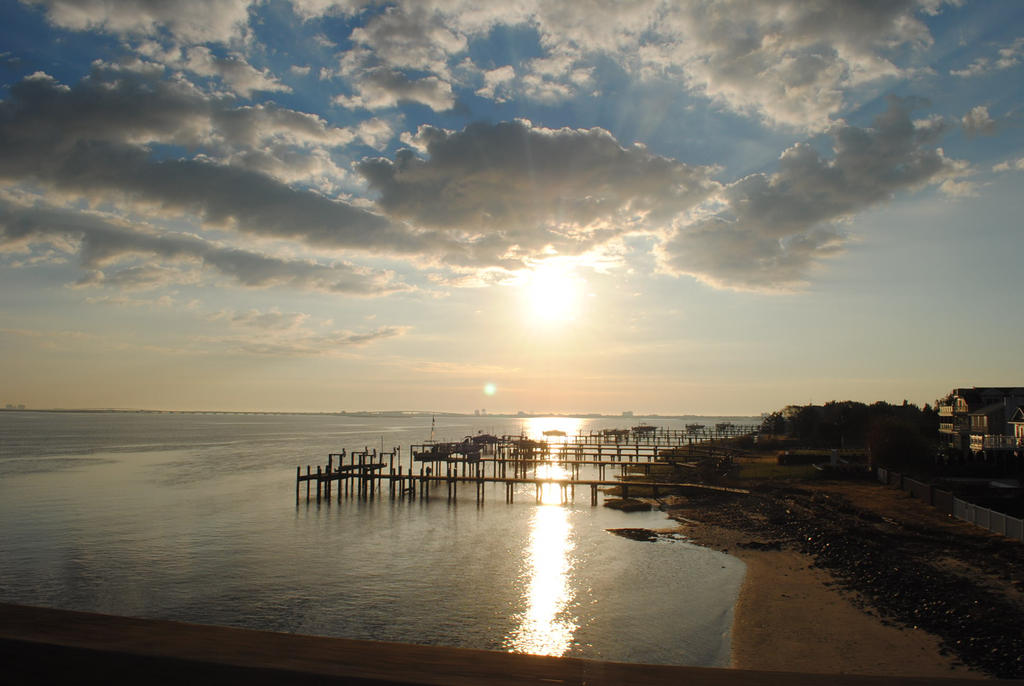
[[0, 0, 1024, 415]]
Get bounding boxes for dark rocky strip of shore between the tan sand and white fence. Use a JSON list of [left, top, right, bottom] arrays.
[[669, 483, 1024, 679]]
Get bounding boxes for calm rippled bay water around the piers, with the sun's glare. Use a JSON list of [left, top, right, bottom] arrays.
[[0, 412, 743, 666]]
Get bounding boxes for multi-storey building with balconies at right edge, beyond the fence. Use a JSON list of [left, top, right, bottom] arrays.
[[936, 386, 1024, 460]]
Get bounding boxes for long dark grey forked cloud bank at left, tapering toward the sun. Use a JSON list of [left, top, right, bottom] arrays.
[[0, 69, 444, 255]]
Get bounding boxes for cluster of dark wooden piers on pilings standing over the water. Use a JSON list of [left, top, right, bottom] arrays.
[[295, 425, 749, 506]]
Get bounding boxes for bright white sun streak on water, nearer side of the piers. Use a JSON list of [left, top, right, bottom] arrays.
[[506, 505, 579, 657]]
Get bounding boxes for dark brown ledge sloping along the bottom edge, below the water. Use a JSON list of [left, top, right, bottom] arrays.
[[0, 604, 1007, 686]]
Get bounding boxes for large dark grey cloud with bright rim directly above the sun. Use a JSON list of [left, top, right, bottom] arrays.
[[356, 120, 716, 264]]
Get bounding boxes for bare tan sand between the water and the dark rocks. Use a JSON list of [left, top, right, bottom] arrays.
[[666, 495, 988, 679]]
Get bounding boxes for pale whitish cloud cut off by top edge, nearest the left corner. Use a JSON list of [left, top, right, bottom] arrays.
[[22, 0, 252, 44]]
